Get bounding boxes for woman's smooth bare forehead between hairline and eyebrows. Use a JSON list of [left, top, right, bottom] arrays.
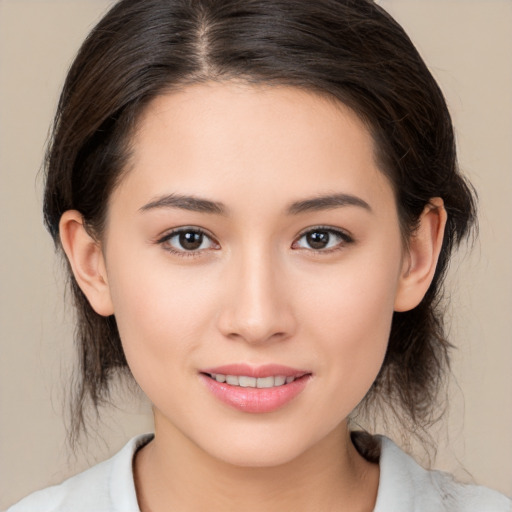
[[115, 82, 396, 216]]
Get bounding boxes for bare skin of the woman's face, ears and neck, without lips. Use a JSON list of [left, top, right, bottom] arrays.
[[61, 82, 446, 512]]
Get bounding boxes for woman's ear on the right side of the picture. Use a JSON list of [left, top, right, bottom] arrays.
[[395, 197, 447, 311]]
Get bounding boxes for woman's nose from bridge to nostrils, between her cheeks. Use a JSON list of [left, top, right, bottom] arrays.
[[218, 247, 296, 344]]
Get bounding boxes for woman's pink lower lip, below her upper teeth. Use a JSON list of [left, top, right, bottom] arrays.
[[201, 374, 311, 413]]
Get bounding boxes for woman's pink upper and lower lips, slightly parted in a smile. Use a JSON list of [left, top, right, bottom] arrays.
[[200, 364, 311, 413]]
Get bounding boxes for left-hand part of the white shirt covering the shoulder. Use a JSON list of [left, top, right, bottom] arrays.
[[7, 434, 152, 512]]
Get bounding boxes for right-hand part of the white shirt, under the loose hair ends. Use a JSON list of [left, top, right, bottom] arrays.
[[375, 437, 512, 512]]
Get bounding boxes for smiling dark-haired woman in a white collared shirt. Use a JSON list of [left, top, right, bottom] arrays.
[[6, 0, 510, 511]]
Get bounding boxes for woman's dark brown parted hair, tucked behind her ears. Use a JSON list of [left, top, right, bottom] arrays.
[[44, 0, 475, 448]]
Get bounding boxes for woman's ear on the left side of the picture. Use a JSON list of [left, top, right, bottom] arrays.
[[59, 210, 114, 316]]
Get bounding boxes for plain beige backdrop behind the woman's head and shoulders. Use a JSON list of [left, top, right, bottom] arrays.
[[0, 0, 512, 508]]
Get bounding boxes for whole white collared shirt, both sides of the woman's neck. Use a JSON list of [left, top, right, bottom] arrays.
[[7, 434, 512, 512]]
